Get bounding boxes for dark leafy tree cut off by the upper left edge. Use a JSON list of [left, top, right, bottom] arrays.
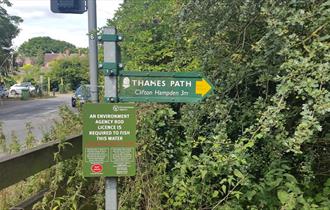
[[0, 0, 23, 77]]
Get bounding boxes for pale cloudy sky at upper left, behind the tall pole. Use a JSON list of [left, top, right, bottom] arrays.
[[6, 0, 123, 48]]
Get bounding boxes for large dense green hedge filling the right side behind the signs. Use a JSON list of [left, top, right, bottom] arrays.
[[109, 0, 330, 209]]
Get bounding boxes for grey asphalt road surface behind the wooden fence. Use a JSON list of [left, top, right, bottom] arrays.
[[0, 94, 71, 153]]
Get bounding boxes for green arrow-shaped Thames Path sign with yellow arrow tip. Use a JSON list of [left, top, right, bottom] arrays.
[[118, 71, 213, 103]]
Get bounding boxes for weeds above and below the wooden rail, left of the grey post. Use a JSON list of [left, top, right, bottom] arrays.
[[0, 106, 103, 209]]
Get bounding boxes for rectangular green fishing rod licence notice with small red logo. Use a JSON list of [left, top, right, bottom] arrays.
[[83, 103, 136, 177]]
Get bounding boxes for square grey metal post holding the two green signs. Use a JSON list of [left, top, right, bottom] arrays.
[[103, 28, 120, 210]]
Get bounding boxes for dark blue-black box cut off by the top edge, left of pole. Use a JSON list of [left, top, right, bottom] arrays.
[[50, 0, 87, 14]]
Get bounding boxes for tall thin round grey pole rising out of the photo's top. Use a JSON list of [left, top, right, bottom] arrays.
[[87, 0, 98, 103]]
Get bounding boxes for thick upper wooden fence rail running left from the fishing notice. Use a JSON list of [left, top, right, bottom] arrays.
[[0, 135, 82, 190]]
